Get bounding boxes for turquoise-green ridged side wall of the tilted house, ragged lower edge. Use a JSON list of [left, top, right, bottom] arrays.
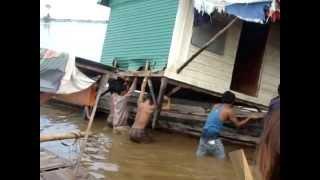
[[101, 0, 178, 70]]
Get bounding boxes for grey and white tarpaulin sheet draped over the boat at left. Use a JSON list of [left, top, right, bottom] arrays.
[[40, 49, 95, 94]]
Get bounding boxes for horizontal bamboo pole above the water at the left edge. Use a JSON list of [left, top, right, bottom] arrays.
[[40, 132, 89, 142]]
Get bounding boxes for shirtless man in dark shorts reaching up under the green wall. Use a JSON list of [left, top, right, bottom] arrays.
[[129, 95, 156, 143]]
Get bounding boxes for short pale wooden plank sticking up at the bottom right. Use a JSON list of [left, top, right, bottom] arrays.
[[229, 149, 253, 180]]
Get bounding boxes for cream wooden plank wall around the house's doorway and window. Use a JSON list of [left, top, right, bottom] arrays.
[[164, 1, 280, 106]]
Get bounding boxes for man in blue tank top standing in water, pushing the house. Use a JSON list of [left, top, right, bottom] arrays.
[[196, 91, 251, 159]]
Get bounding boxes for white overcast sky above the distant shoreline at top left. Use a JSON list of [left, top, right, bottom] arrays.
[[40, 0, 110, 21]]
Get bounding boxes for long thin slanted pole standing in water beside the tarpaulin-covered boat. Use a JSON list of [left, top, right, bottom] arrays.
[[74, 74, 109, 178]]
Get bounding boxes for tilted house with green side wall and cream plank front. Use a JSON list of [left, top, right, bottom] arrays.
[[95, 0, 280, 146]]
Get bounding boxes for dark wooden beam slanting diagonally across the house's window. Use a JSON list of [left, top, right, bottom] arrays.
[[177, 17, 238, 74]]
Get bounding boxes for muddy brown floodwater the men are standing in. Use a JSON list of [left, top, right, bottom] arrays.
[[40, 104, 254, 180]]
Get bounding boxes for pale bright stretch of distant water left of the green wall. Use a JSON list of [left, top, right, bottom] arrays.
[[40, 21, 107, 61]]
